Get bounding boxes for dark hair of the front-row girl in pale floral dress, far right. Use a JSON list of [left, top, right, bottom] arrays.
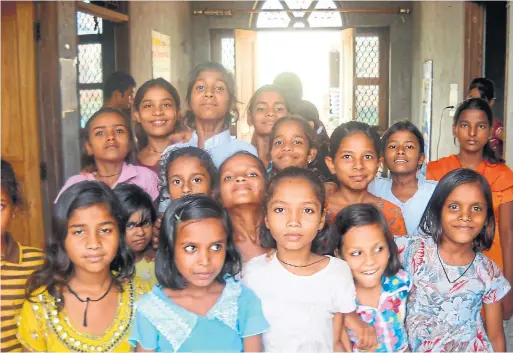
[[420, 168, 495, 251]]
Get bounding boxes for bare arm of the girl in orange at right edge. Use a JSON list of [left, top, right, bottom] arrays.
[[499, 201, 513, 320]]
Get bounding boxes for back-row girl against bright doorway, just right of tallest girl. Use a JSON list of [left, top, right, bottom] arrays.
[[248, 85, 290, 166]]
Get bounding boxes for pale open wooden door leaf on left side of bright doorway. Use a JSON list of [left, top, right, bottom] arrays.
[[235, 29, 257, 142]]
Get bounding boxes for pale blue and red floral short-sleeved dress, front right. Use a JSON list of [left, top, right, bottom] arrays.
[[395, 236, 511, 352]]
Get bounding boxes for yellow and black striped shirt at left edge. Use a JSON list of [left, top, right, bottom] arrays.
[[0, 234, 44, 352]]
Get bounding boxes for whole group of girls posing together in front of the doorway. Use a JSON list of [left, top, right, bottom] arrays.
[[2, 63, 513, 352]]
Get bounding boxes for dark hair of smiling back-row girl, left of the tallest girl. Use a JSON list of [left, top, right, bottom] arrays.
[[134, 77, 181, 150]]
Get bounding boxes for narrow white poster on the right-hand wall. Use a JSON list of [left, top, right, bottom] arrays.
[[422, 60, 433, 163]]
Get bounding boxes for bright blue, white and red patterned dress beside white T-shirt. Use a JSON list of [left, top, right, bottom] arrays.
[[349, 269, 412, 352]]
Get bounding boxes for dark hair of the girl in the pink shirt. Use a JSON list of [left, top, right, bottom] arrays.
[[80, 107, 136, 171]]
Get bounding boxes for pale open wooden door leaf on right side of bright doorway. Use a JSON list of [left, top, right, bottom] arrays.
[[339, 28, 356, 124]]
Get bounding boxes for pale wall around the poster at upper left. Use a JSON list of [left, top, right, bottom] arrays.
[[129, 1, 192, 97]]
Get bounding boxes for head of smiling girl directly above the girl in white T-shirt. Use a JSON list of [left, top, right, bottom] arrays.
[[270, 116, 317, 175]]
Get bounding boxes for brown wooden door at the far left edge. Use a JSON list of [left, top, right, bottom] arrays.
[[1, 1, 44, 247]]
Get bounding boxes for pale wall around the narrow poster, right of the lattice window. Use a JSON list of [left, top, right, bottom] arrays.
[[410, 1, 465, 160]]
